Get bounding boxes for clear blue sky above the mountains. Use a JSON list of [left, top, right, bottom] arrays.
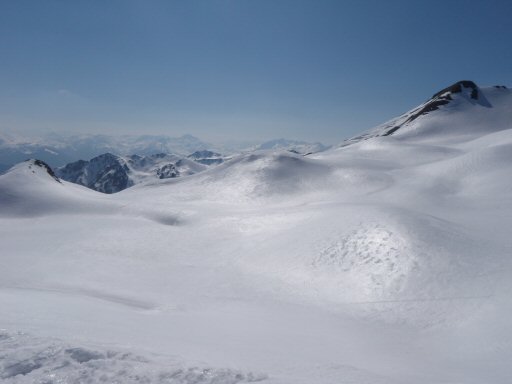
[[0, 0, 512, 143]]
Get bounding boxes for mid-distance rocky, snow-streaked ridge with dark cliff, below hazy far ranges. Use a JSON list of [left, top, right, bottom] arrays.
[[55, 151, 210, 193]]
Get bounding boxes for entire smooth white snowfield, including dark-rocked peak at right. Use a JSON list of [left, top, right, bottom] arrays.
[[0, 80, 512, 383]]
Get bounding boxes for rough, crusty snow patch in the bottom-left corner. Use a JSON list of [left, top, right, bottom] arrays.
[[0, 332, 267, 384]]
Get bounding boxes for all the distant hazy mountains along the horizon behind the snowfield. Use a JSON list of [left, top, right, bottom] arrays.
[[0, 134, 329, 193]]
